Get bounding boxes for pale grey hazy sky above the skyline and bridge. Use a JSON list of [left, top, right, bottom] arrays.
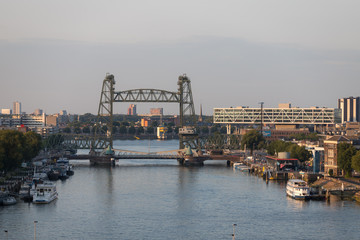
[[0, 0, 360, 115]]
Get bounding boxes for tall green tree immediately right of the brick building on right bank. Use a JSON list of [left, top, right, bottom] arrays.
[[337, 143, 356, 177]]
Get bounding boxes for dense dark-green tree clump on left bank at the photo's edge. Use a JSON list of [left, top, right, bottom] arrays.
[[0, 130, 42, 171]]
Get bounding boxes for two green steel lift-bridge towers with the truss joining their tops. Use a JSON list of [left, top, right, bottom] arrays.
[[91, 74, 200, 150]]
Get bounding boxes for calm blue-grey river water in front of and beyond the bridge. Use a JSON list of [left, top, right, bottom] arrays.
[[0, 140, 360, 240]]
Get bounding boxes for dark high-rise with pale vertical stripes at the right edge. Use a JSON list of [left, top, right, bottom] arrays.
[[338, 97, 360, 123]]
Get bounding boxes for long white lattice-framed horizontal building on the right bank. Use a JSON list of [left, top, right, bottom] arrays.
[[213, 103, 339, 125]]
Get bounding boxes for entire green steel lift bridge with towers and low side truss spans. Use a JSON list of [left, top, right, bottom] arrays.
[[45, 74, 240, 158]]
